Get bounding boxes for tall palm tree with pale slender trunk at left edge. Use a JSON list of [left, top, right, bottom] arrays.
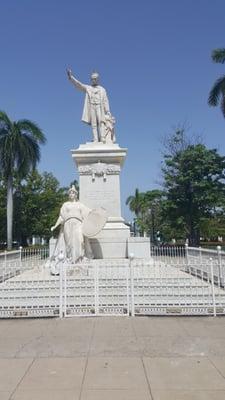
[[0, 111, 46, 250]]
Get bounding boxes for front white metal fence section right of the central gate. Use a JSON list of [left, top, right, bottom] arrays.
[[131, 255, 225, 315]]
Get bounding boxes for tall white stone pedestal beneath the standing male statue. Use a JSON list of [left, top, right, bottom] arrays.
[[71, 142, 130, 258]]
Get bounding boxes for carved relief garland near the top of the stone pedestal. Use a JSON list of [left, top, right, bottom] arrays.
[[78, 161, 120, 181]]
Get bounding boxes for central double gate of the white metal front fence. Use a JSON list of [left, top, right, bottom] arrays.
[[61, 260, 130, 316]]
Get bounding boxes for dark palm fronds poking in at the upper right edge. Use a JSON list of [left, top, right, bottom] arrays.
[[208, 48, 225, 118]]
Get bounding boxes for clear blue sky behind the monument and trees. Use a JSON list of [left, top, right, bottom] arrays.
[[0, 0, 225, 219]]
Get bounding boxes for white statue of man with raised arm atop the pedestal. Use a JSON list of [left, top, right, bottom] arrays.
[[67, 69, 115, 143]]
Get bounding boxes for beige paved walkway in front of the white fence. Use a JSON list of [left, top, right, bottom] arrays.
[[0, 317, 225, 400]]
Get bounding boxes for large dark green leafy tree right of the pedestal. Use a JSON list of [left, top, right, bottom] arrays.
[[163, 144, 225, 245]]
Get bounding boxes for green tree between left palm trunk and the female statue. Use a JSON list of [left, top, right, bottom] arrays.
[[14, 170, 67, 246]]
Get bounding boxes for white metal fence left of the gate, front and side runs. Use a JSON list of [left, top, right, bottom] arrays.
[[0, 248, 57, 318]]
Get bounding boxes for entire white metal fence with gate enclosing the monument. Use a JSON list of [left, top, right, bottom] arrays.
[[0, 246, 225, 318]]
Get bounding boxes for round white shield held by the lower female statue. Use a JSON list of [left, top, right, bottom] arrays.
[[82, 207, 107, 238]]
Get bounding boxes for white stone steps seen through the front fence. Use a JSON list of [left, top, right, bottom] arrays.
[[0, 260, 225, 317]]
